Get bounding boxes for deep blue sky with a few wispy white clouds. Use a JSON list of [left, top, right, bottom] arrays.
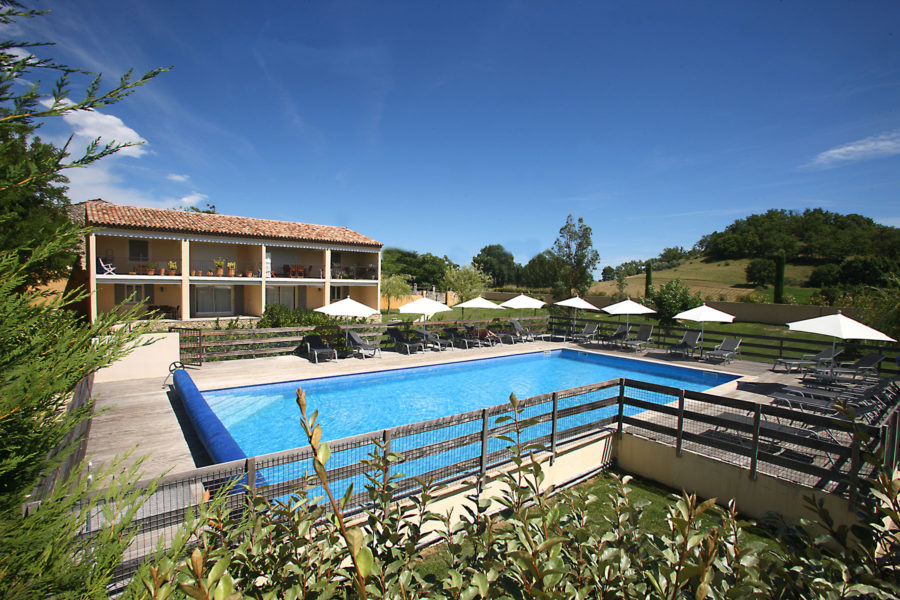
[[0, 0, 900, 271]]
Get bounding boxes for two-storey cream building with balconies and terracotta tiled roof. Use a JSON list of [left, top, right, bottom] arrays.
[[72, 200, 382, 322]]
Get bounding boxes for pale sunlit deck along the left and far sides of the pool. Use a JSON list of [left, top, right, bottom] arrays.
[[87, 341, 797, 477]]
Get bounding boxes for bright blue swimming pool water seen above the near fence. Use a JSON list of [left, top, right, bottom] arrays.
[[203, 349, 735, 456]]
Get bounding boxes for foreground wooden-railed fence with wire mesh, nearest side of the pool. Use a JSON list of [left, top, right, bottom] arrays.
[[86, 379, 900, 582]]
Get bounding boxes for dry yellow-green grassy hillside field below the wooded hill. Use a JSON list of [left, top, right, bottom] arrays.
[[590, 259, 815, 302]]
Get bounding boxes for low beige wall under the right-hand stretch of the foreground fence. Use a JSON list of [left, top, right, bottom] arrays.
[[616, 433, 855, 524]]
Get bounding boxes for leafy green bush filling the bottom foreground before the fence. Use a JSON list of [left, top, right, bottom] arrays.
[[126, 390, 900, 599]]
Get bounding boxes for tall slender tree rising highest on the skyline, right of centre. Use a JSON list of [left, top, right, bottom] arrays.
[[553, 215, 600, 297]]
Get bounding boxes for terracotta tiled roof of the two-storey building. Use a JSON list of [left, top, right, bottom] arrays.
[[78, 200, 382, 248]]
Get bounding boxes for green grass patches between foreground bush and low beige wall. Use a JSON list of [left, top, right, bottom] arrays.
[[412, 472, 777, 578]]
